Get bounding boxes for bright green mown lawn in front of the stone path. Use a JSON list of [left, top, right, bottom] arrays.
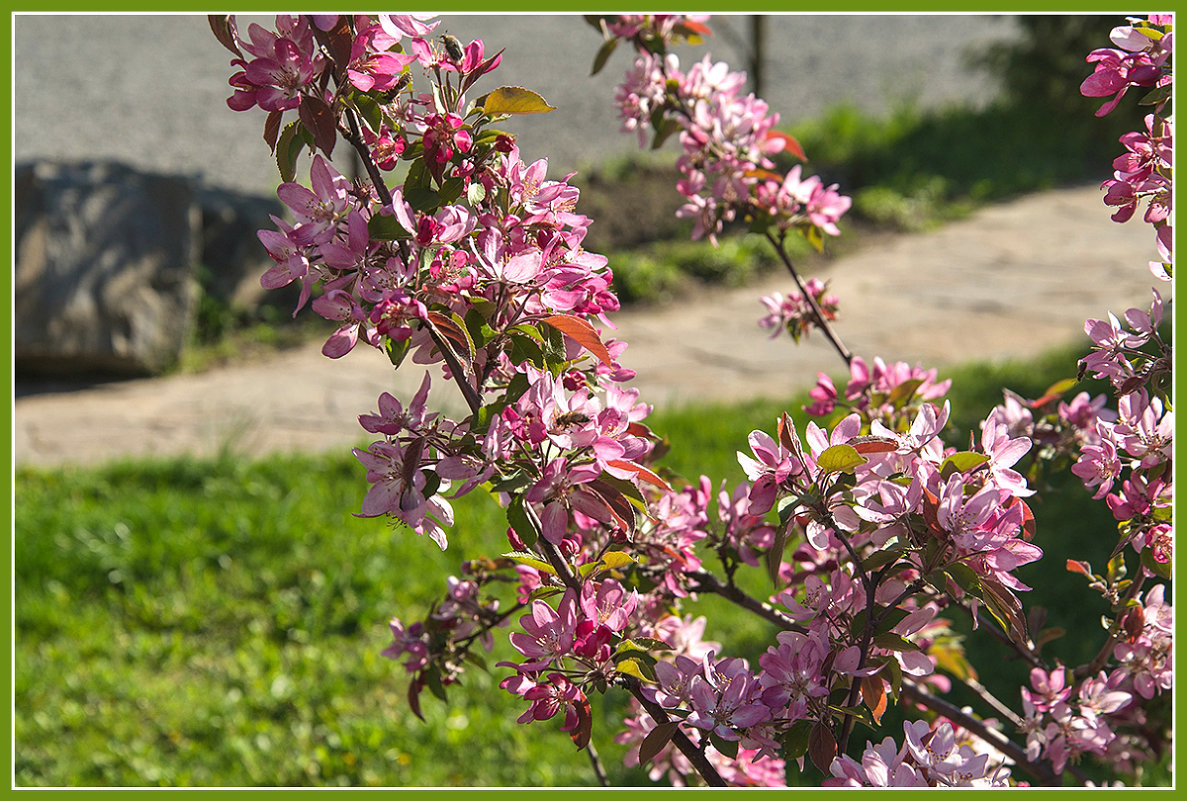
[[14, 339, 1149, 787]]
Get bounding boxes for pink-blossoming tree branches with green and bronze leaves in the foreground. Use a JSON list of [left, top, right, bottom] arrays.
[[211, 14, 1173, 787]]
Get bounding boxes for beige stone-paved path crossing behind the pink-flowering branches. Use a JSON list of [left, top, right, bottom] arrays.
[[13, 187, 1166, 465]]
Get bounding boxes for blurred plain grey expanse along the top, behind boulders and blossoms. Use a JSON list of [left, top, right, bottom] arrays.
[[13, 14, 1016, 193]]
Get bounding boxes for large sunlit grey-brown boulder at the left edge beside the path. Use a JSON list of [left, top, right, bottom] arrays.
[[14, 163, 201, 375]]
